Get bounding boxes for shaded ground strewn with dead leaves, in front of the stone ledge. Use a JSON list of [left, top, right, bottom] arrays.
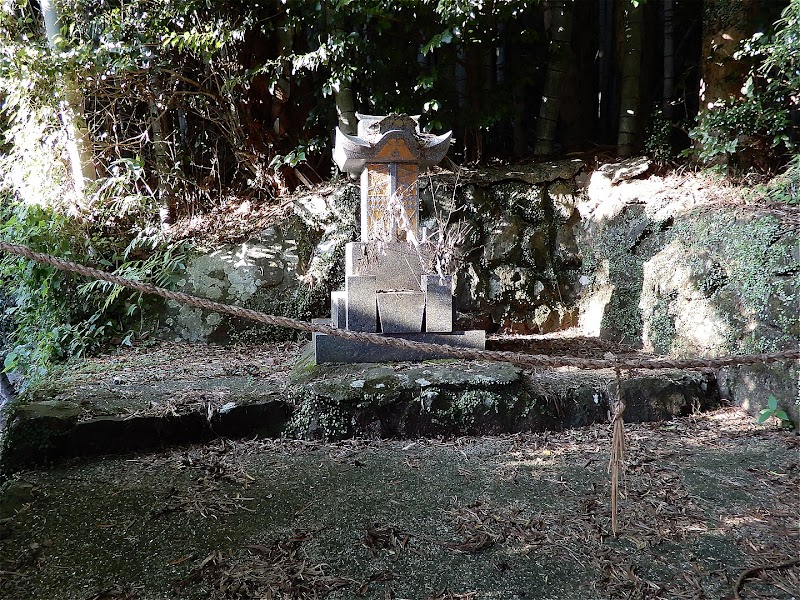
[[0, 408, 800, 600]]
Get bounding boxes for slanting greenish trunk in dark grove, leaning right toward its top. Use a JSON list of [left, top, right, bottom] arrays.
[[533, 0, 574, 156]]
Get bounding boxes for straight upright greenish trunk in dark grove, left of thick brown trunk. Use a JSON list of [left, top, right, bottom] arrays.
[[617, 2, 644, 156]]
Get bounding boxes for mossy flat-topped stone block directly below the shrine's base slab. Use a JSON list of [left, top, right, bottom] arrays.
[[290, 362, 532, 439]]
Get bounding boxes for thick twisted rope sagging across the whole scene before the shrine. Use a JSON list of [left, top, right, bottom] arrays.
[[0, 241, 800, 370]]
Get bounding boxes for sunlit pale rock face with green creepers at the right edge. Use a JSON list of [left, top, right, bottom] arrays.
[[574, 173, 800, 366]]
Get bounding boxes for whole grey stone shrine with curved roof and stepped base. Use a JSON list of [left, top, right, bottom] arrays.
[[313, 114, 486, 364]]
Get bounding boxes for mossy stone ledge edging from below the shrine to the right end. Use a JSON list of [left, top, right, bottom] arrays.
[[291, 361, 719, 439]]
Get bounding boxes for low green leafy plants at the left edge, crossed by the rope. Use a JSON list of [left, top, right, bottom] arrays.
[[0, 197, 187, 387]]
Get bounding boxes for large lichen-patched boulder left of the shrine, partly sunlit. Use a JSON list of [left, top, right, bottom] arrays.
[[158, 184, 358, 343]]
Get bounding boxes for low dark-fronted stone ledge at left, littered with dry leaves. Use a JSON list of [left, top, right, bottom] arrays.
[[0, 384, 291, 472]]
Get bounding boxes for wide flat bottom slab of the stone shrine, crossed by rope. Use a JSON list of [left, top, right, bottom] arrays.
[[313, 329, 486, 365]]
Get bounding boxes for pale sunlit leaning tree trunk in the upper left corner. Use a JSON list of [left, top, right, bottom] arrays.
[[39, 0, 97, 208]]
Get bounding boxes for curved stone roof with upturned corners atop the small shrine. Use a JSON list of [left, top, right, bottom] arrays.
[[333, 113, 452, 175]]
